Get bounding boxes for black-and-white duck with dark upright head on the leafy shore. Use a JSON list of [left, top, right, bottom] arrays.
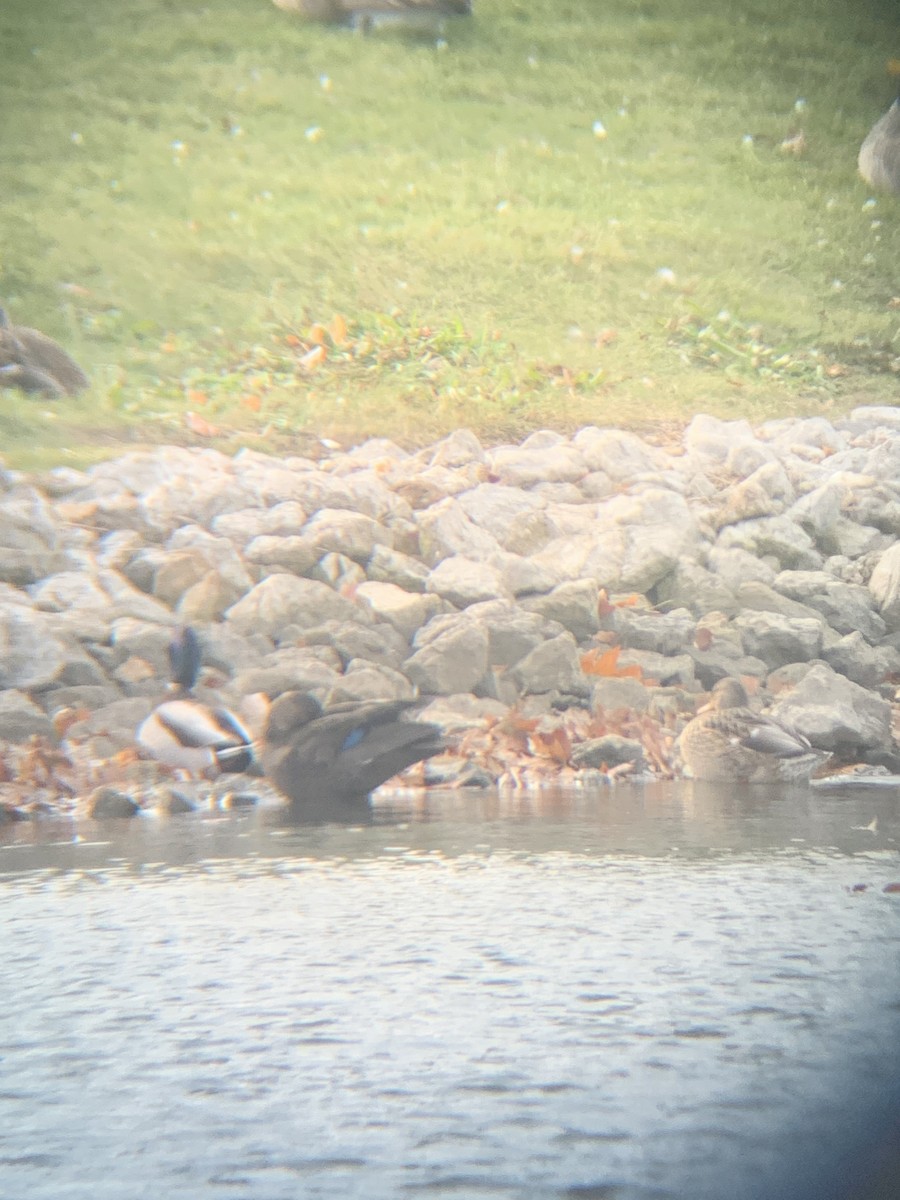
[[137, 625, 256, 774]]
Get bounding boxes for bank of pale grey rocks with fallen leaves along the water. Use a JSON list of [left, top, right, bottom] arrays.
[[0, 408, 900, 815]]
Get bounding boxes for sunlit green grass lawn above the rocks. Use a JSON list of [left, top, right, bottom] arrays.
[[0, 0, 900, 467]]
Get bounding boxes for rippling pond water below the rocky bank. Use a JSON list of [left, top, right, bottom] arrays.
[[0, 785, 900, 1200]]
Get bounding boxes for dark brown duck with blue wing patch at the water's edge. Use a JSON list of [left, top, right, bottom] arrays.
[[260, 691, 444, 821]]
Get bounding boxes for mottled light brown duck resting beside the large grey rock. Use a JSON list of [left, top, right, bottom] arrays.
[[678, 678, 830, 784]]
